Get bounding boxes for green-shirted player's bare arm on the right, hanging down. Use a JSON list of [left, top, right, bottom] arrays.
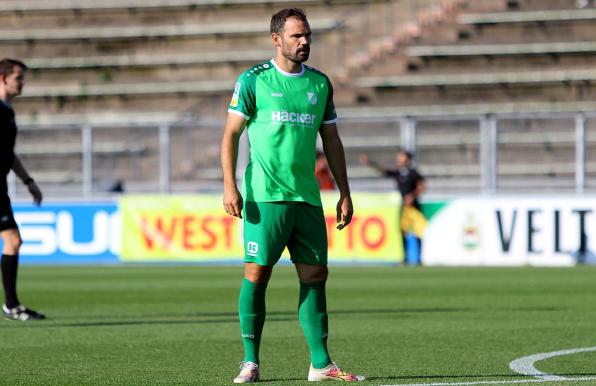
[[319, 123, 354, 230]]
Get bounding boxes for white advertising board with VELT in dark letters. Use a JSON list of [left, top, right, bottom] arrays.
[[423, 195, 596, 266]]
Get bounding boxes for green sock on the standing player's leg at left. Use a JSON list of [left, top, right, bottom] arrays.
[[238, 278, 267, 364]]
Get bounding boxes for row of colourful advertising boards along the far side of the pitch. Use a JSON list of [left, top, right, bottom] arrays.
[[7, 193, 596, 266]]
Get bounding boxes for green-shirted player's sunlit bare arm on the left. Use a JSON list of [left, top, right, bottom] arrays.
[[221, 113, 246, 218]]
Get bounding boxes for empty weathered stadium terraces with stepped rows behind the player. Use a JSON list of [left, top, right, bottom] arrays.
[[0, 0, 596, 193]]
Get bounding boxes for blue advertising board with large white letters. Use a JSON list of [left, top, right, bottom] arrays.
[[13, 201, 121, 264]]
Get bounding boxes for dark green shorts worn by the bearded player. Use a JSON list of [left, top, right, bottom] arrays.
[[244, 201, 327, 267]]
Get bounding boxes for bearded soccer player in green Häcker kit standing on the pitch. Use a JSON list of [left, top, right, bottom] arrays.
[[221, 8, 364, 383]]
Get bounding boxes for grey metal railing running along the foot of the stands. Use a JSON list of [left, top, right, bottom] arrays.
[[9, 110, 596, 198]]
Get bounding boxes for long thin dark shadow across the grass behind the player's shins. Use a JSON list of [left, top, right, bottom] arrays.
[[0, 308, 469, 329]]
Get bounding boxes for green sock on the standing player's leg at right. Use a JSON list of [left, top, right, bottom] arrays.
[[298, 282, 331, 369]]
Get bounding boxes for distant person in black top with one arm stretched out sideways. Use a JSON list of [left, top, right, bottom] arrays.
[[360, 149, 426, 263]]
